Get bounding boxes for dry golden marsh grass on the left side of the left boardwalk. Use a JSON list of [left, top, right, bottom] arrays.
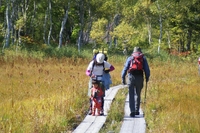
[[0, 57, 120, 133]]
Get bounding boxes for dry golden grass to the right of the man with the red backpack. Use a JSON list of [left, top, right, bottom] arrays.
[[146, 59, 200, 133]]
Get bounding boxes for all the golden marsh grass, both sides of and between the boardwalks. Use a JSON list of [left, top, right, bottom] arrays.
[[0, 49, 200, 133]]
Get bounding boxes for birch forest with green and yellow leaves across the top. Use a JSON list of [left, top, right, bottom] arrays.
[[0, 0, 200, 52]]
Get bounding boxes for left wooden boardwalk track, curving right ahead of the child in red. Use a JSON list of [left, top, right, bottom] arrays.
[[73, 85, 126, 133]]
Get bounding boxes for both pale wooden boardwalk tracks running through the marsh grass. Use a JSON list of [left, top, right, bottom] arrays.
[[73, 85, 145, 133]]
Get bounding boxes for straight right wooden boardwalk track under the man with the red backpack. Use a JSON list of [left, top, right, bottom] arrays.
[[120, 95, 146, 133]]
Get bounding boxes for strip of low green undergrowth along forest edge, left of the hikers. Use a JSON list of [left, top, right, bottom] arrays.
[[0, 44, 86, 60]]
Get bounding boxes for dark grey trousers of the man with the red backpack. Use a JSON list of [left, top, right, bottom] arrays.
[[127, 73, 144, 112]]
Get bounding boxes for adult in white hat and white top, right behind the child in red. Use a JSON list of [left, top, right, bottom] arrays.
[[86, 53, 115, 115]]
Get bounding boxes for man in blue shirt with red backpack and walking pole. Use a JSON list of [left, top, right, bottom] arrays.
[[121, 47, 150, 117]]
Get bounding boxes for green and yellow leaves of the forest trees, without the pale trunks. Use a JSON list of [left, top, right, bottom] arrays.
[[0, 0, 200, 53]]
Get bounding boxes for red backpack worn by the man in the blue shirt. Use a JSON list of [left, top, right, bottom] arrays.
[[128, 52, 144, 72]]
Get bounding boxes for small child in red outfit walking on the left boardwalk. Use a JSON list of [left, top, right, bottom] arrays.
[[91, 80, 103, 116]]
